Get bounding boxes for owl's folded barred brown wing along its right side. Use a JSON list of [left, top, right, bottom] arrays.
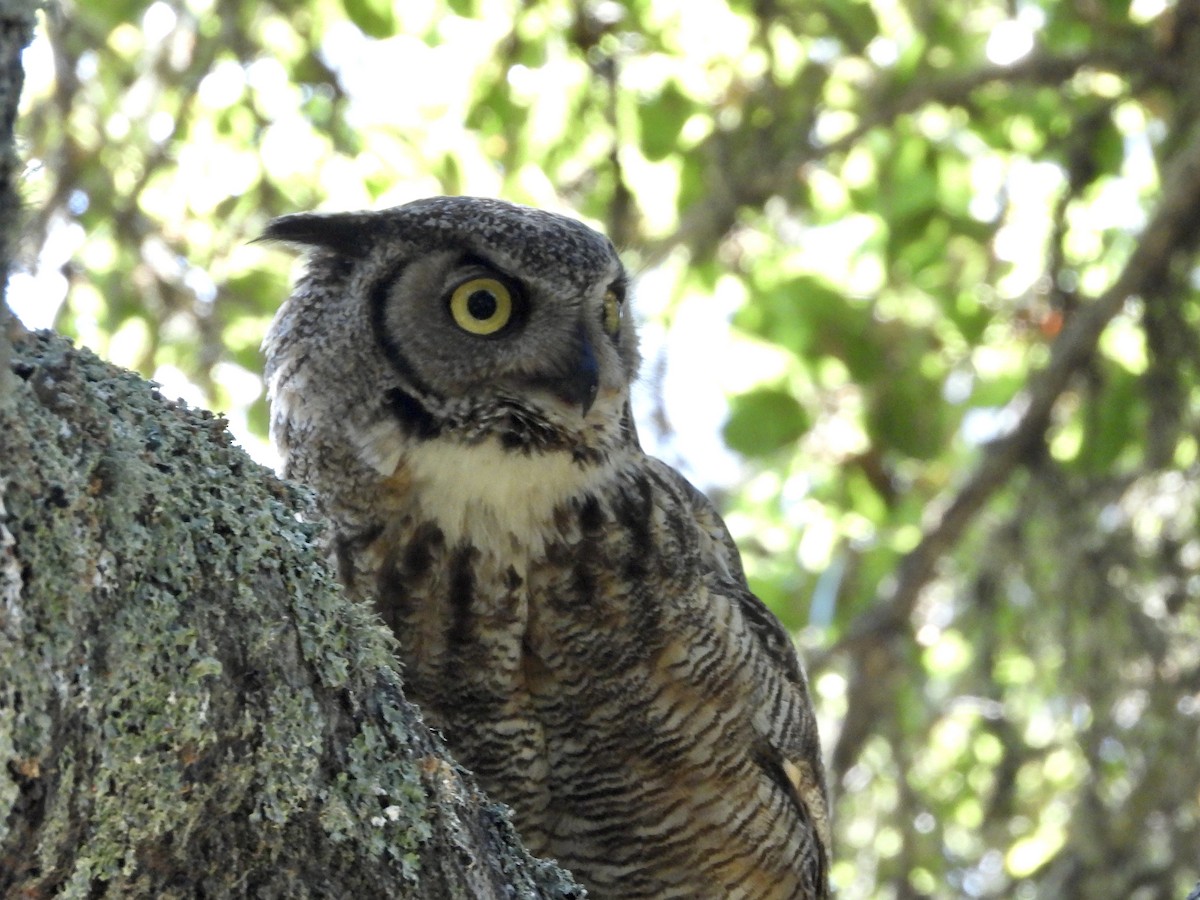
[[654, 460, 830, 884]]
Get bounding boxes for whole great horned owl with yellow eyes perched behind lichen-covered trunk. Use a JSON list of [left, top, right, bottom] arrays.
[[264, 197, 829, 898]]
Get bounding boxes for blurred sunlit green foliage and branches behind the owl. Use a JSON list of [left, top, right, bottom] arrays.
[[11, 0, 1200, 899]]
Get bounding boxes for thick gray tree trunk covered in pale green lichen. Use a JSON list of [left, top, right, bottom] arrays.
[[0, 0, 583, 898]]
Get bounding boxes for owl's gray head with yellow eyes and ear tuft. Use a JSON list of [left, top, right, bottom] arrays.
[[263, 197, 638, 480]]
